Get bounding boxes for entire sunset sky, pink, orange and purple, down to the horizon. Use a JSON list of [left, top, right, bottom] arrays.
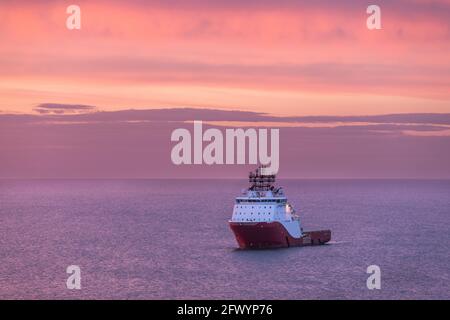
[[0, 0, 450, 178]]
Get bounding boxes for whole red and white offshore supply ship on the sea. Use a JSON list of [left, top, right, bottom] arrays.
[[229, 166, 331, 249]]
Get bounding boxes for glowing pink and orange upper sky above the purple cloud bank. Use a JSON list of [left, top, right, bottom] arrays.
[[0, 0, 450, 115]]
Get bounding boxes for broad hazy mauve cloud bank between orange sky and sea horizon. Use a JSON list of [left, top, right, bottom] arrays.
[[0, 105, 450, 178]]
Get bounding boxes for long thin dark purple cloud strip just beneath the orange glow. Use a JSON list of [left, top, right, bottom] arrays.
[[7, 103, 450, 131]]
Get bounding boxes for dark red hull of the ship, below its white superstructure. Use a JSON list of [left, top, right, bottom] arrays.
[[230, 222, 331, 249]]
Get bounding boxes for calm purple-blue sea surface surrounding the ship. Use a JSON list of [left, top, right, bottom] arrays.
[[0, 179, 450, 299]]
